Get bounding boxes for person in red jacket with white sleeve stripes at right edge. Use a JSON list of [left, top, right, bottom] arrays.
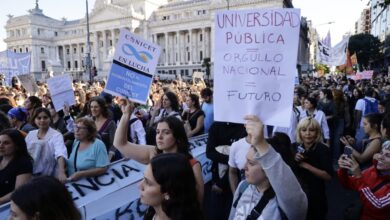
[[338, 116, 390, 220]]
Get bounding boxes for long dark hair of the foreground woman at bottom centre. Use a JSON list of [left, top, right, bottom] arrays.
[[144, 153, 202, 220]]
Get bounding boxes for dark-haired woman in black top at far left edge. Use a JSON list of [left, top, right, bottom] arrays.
[[0, 129, 33, 205]]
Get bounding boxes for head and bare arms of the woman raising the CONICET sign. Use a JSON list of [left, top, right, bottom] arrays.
[[114, 100, 204, 203]]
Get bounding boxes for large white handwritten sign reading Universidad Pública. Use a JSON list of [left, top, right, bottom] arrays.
[[214, 9, 300, 127]]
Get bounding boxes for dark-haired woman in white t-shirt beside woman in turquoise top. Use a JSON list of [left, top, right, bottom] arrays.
[[26, 107, 68, 182]]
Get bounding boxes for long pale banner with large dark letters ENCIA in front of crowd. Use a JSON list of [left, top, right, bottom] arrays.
[[0, 134, 211, 220]]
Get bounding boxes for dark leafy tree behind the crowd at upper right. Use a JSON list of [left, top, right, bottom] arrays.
[[348, 33, 383, 69]]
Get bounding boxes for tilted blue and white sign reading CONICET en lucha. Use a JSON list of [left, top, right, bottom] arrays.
[[104, 29, 160, 104]]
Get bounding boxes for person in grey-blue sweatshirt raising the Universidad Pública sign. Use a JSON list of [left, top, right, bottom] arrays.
[[229, 115, 308, 220]]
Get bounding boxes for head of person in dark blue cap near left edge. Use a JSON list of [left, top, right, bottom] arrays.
[[8, 107, 37, 133]]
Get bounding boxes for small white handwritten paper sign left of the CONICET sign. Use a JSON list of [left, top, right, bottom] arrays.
[[47, 74, 76, 112]]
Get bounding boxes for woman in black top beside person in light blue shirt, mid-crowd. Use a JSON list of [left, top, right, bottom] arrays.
[[182, 94, 205, 137]]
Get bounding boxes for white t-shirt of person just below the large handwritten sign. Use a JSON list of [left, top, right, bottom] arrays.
[[228, 137, 251, 170]]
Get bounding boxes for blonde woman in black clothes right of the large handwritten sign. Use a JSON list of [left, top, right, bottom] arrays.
[[293, 117, 333, 220]]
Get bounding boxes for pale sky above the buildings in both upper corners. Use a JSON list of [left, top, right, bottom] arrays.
[[0, 0, 369, 51]]
